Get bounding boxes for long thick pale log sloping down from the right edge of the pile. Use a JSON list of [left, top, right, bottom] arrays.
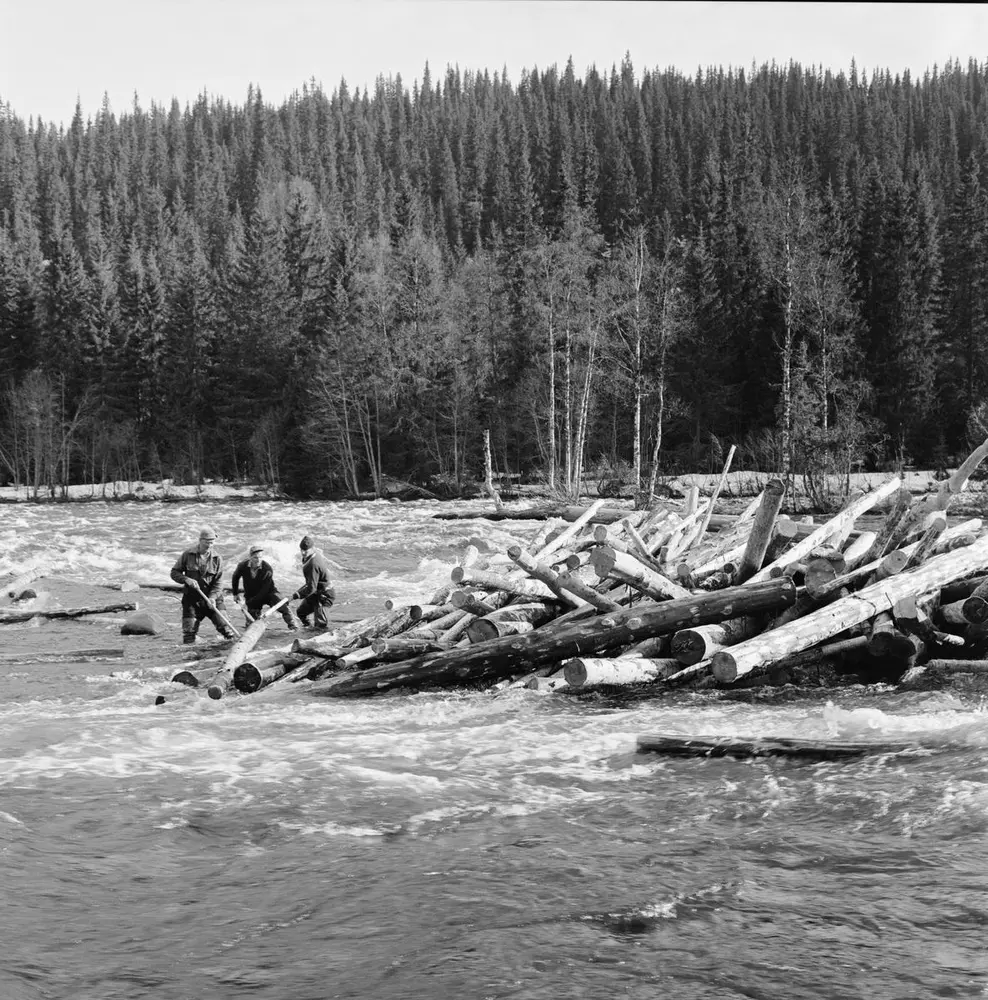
[[711, 538, 988, 684]]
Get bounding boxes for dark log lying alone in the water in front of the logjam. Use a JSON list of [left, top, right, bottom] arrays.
[[638, 735, 914, 761]]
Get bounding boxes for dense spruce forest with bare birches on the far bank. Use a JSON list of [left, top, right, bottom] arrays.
[[0, 59, 988, 496]]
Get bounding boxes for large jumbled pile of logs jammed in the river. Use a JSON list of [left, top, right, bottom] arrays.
[[191, 441, 988, 697]]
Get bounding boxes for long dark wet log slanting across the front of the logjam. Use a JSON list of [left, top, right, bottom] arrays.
[[311, 580, 796, 696]]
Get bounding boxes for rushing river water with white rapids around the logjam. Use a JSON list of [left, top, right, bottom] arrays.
[[0, 502, 988, 1000]]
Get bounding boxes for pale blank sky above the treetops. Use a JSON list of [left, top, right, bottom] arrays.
[[0, 0, 988, 123]]
